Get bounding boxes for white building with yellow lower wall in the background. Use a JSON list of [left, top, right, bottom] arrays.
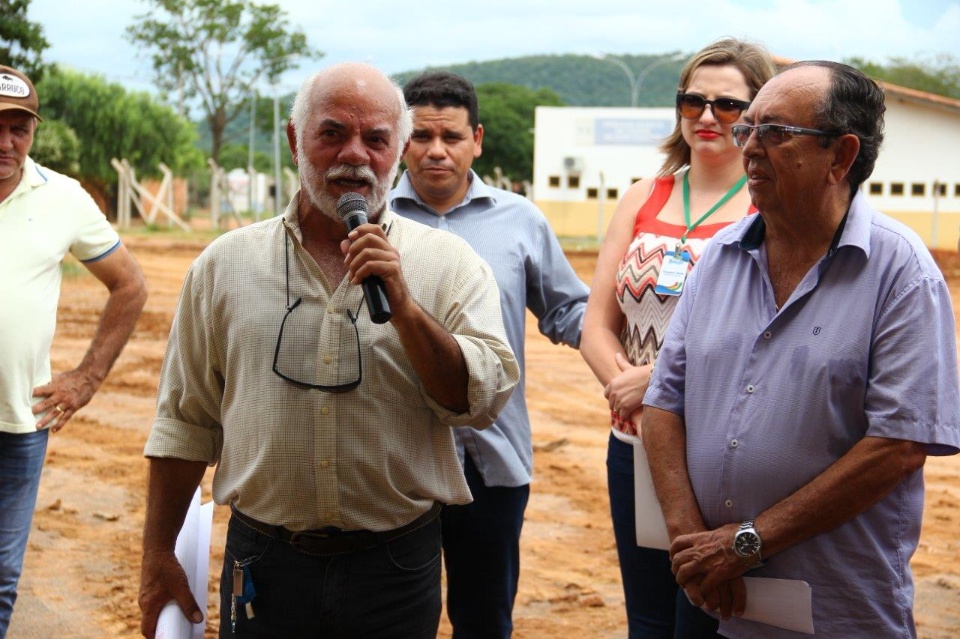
[[533, 85, 960, 249]]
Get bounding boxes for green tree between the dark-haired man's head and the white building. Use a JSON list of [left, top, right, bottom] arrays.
[[473, 82, 563, 182]]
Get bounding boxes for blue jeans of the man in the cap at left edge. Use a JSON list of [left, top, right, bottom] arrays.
[[0, 430, 50, 639]]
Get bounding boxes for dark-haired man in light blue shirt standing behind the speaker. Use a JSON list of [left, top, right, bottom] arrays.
[[389, 72, 589, 639]]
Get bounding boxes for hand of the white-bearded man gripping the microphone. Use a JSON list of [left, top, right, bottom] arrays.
[[340, 223, 413, 315]]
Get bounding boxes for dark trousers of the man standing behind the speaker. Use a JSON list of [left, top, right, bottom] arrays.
[[440, 455, 530, 639]]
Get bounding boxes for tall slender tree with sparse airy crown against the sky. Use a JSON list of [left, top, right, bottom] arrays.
[[127, 0, 322, 162]]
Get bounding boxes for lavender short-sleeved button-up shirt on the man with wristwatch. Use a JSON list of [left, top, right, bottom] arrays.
[[644, 193, 960, 638]]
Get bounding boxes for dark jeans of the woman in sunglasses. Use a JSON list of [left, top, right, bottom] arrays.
[[607, 434, 719, 639]]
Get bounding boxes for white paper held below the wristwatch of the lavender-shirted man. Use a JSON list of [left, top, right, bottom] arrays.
[[741, 577, 813, 635]]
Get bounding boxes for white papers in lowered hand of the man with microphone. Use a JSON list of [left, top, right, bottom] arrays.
[[156, 488, 213, 639]]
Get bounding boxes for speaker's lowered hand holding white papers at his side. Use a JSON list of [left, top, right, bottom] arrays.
[[138, 551, 203, 639]]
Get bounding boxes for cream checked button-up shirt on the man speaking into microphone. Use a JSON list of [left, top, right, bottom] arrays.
[[145, 198, 519, 530]]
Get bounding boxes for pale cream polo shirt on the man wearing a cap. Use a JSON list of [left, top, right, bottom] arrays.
[[0, 157, 120, 433]]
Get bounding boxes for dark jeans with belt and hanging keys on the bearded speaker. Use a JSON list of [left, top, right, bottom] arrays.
[[220, 508, 442, 639]]
